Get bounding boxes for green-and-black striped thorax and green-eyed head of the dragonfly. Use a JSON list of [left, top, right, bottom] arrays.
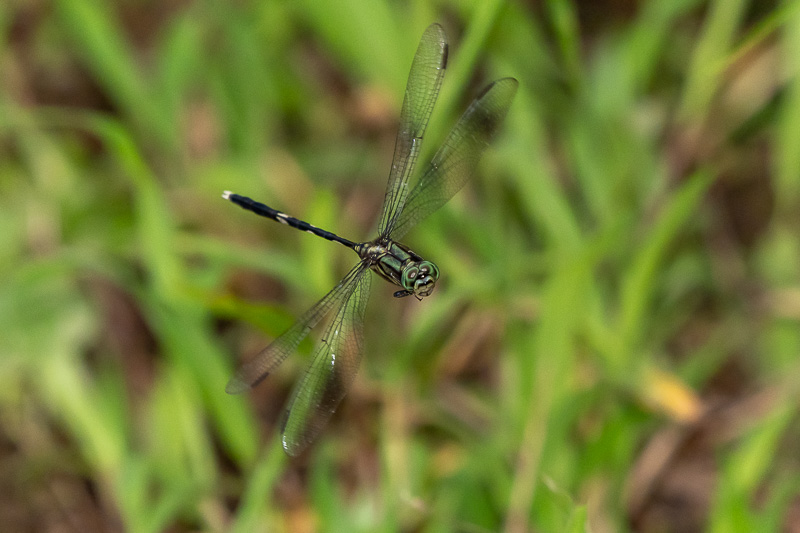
[[354, 240, 439, 300]]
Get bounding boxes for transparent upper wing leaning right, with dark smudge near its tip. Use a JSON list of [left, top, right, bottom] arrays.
[[390, 78, 518, 240]]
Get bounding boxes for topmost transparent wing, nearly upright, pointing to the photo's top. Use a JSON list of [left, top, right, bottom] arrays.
[[378, 24, 447, 236]]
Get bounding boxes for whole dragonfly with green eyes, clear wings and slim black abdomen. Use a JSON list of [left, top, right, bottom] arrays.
[[222, 23, 518, 456]]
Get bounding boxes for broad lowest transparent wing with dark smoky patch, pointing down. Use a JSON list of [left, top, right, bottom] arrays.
[[282, 269, 370, 455]]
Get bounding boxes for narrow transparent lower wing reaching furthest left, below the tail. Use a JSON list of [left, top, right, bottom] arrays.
[[225, 262, 368, 394]]
